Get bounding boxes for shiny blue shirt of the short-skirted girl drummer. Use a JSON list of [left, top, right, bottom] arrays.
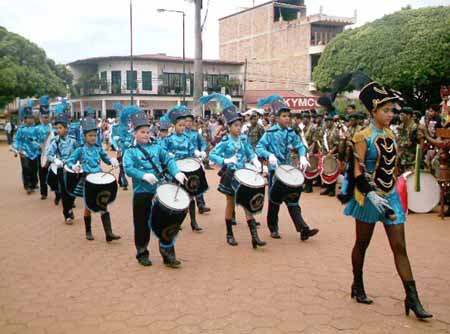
[[209, 135, 256, 170]]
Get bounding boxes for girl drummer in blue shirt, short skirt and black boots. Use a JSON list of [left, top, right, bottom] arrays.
[[209, 97, 266, 248]]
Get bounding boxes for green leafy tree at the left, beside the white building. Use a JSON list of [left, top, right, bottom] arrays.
[[0, 26, 72, 107]]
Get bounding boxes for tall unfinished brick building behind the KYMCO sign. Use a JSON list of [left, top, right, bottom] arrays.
[[219, 0, 356, 104]]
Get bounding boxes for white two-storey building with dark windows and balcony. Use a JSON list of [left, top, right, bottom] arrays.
[[68, 54, 244, 118]]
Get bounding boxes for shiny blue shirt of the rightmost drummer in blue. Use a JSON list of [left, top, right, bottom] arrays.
[[256, 124, 306, 170]]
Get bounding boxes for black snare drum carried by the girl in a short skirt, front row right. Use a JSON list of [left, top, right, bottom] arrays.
[[231, 168, 266, 214]]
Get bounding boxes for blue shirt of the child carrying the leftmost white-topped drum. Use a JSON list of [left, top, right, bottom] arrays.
[[67, 144, 111, 174]]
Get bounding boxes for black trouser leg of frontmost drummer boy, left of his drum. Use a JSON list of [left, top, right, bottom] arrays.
[[133, 193, 154, 258]]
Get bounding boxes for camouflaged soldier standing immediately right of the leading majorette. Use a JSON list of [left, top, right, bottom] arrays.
[[397, 107, 418, 174]]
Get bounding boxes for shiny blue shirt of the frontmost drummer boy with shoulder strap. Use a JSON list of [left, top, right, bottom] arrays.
[[123, 142, 180, 194]]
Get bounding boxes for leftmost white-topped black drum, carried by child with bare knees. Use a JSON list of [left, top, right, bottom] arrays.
[[84, 172, 117, 212]]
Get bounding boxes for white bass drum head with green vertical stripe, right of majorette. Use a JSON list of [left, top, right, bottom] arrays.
[[406, 171, 441, 213]]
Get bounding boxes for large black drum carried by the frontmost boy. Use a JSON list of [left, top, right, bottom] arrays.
[[150, 183, 191, 245]]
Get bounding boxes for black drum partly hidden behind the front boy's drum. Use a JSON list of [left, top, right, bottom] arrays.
[[177, 158, 208, 196]]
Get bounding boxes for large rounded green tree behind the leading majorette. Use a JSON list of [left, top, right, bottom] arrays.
[[313, 6, 450, 110]]
